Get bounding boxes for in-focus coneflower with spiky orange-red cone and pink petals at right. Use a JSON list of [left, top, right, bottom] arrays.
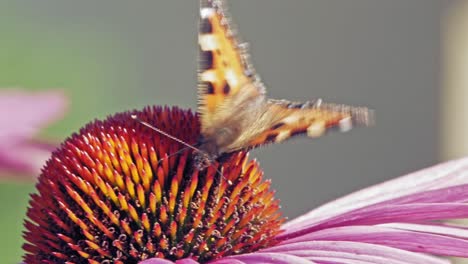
[[24, 107, 468, 264]]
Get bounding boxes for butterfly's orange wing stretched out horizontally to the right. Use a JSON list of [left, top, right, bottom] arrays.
[[228, 99, 374, 152]]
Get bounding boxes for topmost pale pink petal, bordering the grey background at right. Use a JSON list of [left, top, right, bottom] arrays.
[[283, 158, 468, 231]]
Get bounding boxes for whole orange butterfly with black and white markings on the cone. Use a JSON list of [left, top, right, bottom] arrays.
[[195, 0, 373, 169]]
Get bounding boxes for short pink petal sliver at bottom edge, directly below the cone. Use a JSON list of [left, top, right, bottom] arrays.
[[210, 252, 316, 264]]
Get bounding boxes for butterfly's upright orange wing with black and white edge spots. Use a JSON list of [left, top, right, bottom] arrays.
[[198, 0, 264, 133]]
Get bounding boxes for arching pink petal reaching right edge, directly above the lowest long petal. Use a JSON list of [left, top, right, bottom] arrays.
[[287, 226, 468, 257]]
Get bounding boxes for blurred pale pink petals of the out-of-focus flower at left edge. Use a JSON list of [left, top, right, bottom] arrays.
[[0, 90, 68, 174]]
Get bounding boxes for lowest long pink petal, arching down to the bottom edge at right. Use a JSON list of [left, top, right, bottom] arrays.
[[262, 240, 450, 264]]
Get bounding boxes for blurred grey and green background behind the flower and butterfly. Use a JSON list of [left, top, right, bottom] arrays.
[[0, 0, 468, 263]]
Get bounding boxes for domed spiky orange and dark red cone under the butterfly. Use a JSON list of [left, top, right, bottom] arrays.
[[23, 107, 283, 264]]
